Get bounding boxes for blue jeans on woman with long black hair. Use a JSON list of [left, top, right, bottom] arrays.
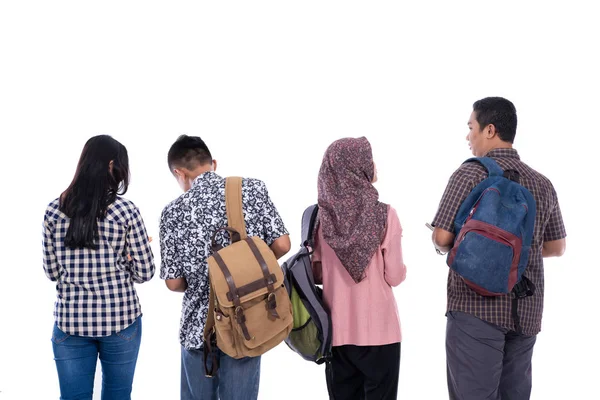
[[52, 316, 142, 400]]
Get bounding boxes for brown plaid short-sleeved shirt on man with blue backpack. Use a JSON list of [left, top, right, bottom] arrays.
[[432, 149, 567, 335]]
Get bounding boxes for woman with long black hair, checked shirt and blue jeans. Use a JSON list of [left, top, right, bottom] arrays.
[[43, 135, 155, 400]]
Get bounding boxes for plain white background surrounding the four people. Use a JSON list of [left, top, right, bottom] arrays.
[[0, 0, 600, 400]]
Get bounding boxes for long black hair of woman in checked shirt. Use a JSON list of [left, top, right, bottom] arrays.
[[60, 135, 129, 249]]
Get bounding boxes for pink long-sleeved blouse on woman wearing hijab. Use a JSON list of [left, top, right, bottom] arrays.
[[312, 206, 406, 346]]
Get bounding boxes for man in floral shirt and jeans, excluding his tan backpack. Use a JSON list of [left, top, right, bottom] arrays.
[[160, 135, 290, 400]]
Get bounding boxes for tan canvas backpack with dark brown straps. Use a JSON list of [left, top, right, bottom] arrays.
[[204, 177, 293, 376]]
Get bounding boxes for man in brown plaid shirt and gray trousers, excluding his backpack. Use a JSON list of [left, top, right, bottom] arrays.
[[432, 97, 566, 400]]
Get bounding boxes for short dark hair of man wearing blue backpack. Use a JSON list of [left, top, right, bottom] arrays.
[[473, 97, 517, 143]]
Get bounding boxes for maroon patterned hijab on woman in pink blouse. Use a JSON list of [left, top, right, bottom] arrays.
[[318, 137, 387, 283]]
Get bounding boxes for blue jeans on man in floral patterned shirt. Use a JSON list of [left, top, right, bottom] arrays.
[[181, 346, 260, 400]]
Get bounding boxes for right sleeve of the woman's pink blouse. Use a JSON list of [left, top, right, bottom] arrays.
[[381, 206, 406, 286]]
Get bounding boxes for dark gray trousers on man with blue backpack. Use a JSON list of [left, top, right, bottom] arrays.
[[446, 311, 536, 400]]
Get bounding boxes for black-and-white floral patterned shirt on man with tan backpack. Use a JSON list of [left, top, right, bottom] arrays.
[[160, 172, 288, 350]]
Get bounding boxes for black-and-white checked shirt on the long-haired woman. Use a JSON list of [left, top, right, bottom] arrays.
[[43, 197, 155, 337]]
